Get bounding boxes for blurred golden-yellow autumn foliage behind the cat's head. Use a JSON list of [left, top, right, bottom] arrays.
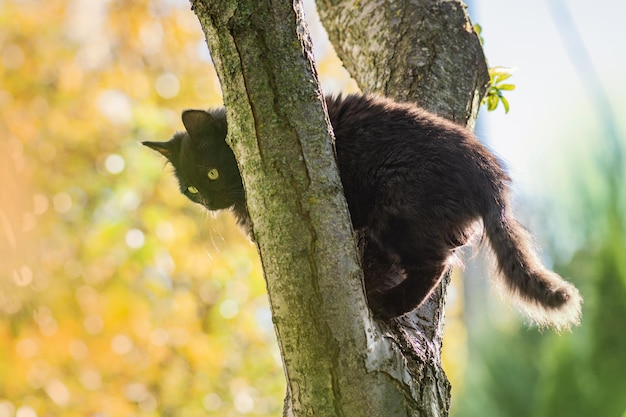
[[0, 0, 466, 417]]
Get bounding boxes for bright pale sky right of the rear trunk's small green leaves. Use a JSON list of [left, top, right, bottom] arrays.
[[470, 0, 626, 192]]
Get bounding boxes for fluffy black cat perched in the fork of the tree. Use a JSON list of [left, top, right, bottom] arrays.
[[144, 95, 582, 329]]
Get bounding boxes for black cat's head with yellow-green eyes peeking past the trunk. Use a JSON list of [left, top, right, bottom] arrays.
[[142, 109, 245, 210]]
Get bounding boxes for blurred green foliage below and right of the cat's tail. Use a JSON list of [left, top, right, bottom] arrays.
[[452, 106, 626, 417]]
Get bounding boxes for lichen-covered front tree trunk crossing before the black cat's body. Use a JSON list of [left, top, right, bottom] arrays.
[[191, 0, 488, 417]]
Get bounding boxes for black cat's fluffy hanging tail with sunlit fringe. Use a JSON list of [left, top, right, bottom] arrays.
[[483, 205, 582, 330]]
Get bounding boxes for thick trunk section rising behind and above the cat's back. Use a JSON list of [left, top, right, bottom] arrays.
[[316, 0, 489, 128]]
